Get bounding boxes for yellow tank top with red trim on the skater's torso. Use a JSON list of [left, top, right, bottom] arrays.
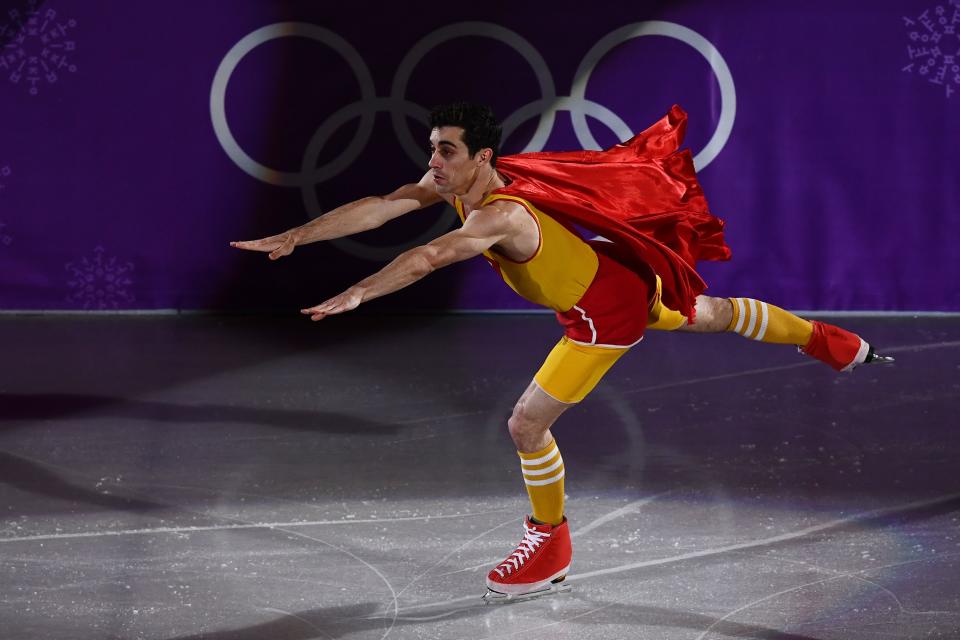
[[455, 193, 599, 312]]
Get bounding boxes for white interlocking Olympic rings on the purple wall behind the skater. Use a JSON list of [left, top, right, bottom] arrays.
[[210, 20, 737, 261]]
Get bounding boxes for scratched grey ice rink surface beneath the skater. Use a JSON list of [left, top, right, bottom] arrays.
[[0, 314, 960, 640]]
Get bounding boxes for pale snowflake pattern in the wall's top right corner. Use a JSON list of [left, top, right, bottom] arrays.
[[903, 0, 960, 98]]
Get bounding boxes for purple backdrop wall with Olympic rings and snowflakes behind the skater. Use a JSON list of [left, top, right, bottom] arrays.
[[0, 0, 960, 311]]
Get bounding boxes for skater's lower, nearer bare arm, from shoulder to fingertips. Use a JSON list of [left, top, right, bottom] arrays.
[[300, 206, 512, 320]]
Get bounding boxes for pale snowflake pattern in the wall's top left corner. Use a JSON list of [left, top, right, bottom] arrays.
[[0, 0, 77, 96]]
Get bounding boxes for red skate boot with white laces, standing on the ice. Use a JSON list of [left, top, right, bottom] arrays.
[[487, 517, 573, 598]]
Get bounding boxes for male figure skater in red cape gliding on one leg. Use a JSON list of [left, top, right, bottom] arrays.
[[231, 103, 889, 597]]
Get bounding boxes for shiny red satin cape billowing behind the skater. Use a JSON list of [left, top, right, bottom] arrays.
[[494, 105, 730, 320]]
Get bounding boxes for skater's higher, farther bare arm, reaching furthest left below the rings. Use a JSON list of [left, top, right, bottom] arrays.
[[230, 173, 441, 260]]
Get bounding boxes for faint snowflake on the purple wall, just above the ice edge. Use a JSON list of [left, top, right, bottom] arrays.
[[64, 246, 134, 310]]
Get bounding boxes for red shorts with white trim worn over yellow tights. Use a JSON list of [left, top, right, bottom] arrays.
[[557, 248, 651, 348]]
